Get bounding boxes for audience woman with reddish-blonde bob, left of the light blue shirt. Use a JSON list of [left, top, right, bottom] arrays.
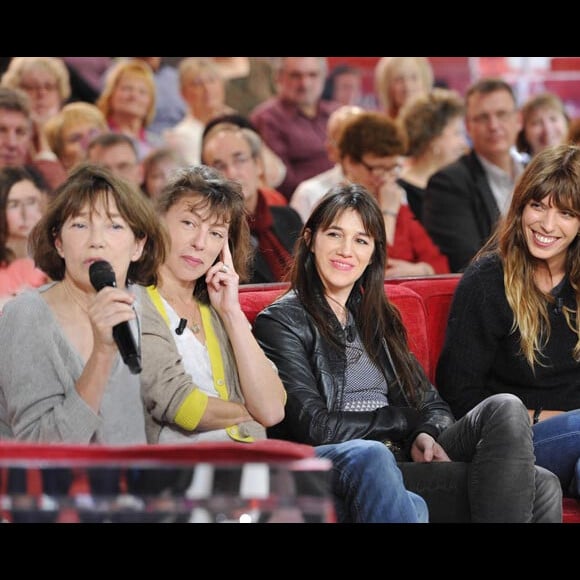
[[96, 59, 162, 161]]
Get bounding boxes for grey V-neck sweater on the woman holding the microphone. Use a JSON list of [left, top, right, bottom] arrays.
[[0, 285, 146, 445]]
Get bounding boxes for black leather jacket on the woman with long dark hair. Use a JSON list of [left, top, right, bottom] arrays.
[[254, 292, 454, 446]]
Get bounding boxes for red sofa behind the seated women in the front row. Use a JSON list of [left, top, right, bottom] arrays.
[[240, 274, 580, 523]]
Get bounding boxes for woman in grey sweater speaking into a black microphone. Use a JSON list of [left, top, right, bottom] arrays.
[[0, 165, 165, 445]]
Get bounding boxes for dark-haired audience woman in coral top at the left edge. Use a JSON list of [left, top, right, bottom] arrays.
[[0, 166, 48, 309]]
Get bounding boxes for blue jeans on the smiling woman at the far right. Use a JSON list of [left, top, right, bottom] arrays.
[[532, 409, 580, 497]]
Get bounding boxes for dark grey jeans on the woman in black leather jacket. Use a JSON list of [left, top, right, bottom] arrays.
[[399, 394, 562, 523]]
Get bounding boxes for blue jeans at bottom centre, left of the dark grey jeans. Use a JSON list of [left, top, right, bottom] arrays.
[[315, 439, 429, 523]]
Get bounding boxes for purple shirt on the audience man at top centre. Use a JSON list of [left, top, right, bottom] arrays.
[[250, 97, 340, 199]]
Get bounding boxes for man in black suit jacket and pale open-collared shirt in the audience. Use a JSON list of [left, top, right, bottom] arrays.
[[423, 78, 523, 272]]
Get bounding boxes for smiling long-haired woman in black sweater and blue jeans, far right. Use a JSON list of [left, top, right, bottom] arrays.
[[437, 145, 580, 497]]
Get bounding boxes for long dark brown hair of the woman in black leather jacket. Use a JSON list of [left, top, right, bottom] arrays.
[[290, 184, 429, 402]]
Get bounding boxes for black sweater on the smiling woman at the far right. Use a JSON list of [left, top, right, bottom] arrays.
[[436, 256, 580, 417]]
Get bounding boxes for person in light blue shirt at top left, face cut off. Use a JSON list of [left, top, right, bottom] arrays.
[[133, 56, 187, 138]]
